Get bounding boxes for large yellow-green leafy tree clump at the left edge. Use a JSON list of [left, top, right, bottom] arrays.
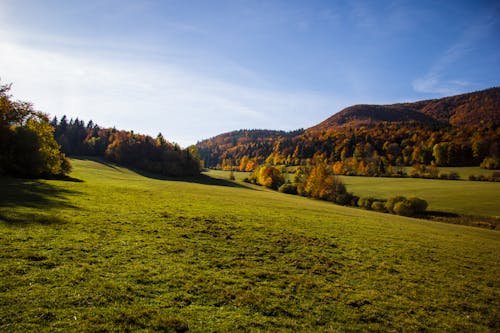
[[0, 81, 71, 178]]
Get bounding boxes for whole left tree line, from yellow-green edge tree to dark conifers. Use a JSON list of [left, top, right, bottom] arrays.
[[0, 81, 201, 178]]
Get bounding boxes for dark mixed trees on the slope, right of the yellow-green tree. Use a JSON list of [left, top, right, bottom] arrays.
[[52, 116, 201, 176]]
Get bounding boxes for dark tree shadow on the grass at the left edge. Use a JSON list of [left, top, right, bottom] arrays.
[[0, 177, 78, 226]]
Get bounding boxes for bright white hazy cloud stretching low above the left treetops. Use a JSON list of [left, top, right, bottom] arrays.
[[0, 31, 340, 145]]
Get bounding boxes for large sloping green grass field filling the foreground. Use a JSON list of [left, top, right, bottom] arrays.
[[0, 160, 500, 332]]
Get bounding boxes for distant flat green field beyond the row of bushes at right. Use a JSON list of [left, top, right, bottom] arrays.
[[341, 176, 500, 216]]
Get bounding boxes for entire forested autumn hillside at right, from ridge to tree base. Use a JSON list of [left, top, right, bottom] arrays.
[[198, 88, 500, 175]]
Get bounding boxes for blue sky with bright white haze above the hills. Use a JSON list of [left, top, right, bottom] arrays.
[[0, 0, 500, 147]]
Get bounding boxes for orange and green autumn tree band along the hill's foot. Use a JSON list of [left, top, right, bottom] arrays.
[[198, 123, 500, 176]]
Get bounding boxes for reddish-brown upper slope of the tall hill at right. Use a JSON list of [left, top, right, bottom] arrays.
[[308, 88, 500, 132]]
